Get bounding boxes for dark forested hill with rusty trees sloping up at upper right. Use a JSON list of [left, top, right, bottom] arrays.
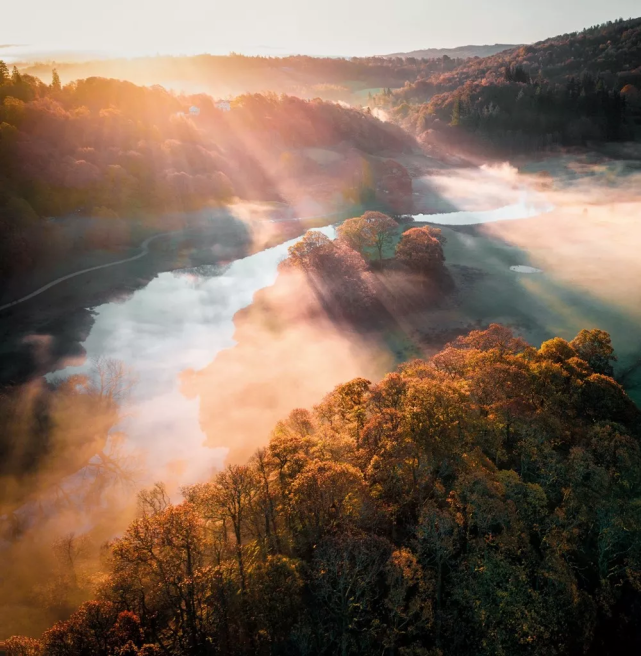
[[375, 19, 641, 153]]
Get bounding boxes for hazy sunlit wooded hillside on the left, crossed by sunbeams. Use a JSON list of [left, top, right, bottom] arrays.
[[0, 63, 413, 278]]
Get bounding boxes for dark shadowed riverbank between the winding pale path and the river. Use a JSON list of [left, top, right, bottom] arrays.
[[0, 208, 350, 385]]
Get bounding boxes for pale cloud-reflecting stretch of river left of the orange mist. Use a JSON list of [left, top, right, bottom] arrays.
[[48, 227, 334, 484]]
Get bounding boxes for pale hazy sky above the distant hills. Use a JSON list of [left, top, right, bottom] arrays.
[[0, 0, 641, 57]]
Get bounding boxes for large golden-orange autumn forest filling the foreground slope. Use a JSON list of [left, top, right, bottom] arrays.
[[1, 324, 641, 656]]
